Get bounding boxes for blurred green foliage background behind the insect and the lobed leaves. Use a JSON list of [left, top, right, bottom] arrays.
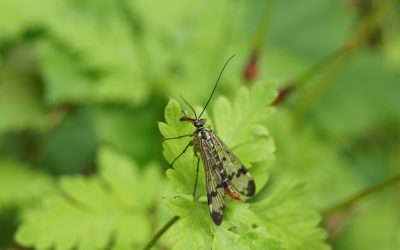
[[0, 0, 400, 249]]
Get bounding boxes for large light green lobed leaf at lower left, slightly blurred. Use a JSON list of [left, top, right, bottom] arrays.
[[16, 148, 162, 249]]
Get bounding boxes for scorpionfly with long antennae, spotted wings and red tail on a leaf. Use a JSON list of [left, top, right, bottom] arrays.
[[163, 55, 256, 226]]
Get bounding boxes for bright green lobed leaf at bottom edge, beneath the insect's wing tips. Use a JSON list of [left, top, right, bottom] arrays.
[[166, 197, 286, 250]]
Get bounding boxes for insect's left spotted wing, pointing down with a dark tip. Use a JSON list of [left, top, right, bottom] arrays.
[[200, 140, 226, 226]]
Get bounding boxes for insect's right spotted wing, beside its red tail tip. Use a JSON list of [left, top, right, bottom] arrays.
[[212, 133, 256, 196]]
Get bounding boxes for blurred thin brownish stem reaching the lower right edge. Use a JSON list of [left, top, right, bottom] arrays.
[[321, 174, 400, 218]]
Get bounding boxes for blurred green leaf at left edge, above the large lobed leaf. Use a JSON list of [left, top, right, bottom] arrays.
[[0, 159, 56, 207]]
